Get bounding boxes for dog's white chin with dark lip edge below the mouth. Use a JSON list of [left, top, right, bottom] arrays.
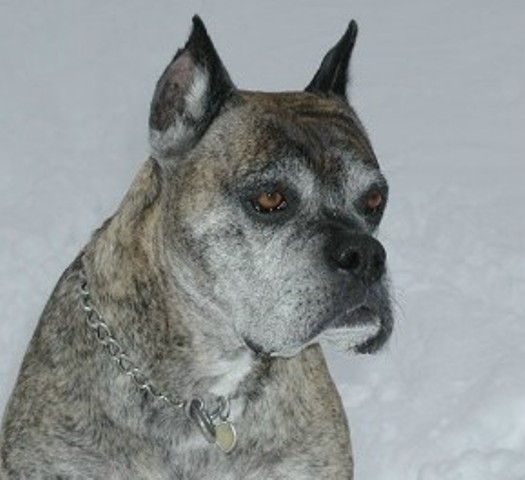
[[319, 306, 392, 353]]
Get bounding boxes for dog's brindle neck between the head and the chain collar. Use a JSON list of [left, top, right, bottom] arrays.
[[78, 160, 257, 404]]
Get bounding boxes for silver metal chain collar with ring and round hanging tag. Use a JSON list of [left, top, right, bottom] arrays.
[[79, 267, 237, 453]]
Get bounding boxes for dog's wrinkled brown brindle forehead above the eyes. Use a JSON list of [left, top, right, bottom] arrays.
[[223, 92, 380, 187]]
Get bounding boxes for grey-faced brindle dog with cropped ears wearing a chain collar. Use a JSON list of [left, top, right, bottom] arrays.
[[0, 16, 393, 480]]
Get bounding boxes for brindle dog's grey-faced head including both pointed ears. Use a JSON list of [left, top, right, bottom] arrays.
[[149, 17, 392, 356]]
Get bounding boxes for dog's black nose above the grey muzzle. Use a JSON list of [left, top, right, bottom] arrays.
[[327, 233, 386, 285]]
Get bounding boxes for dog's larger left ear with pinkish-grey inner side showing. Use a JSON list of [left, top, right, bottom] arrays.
[[149, 16, 235, 159]]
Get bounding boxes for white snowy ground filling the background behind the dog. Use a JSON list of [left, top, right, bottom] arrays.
[[0, 0, 525, 480]]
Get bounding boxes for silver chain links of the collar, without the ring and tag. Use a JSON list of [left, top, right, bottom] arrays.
[[80, 271, 186, 408]]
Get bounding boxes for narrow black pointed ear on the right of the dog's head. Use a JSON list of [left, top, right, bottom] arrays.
[[305, 20, 357, 100]]
